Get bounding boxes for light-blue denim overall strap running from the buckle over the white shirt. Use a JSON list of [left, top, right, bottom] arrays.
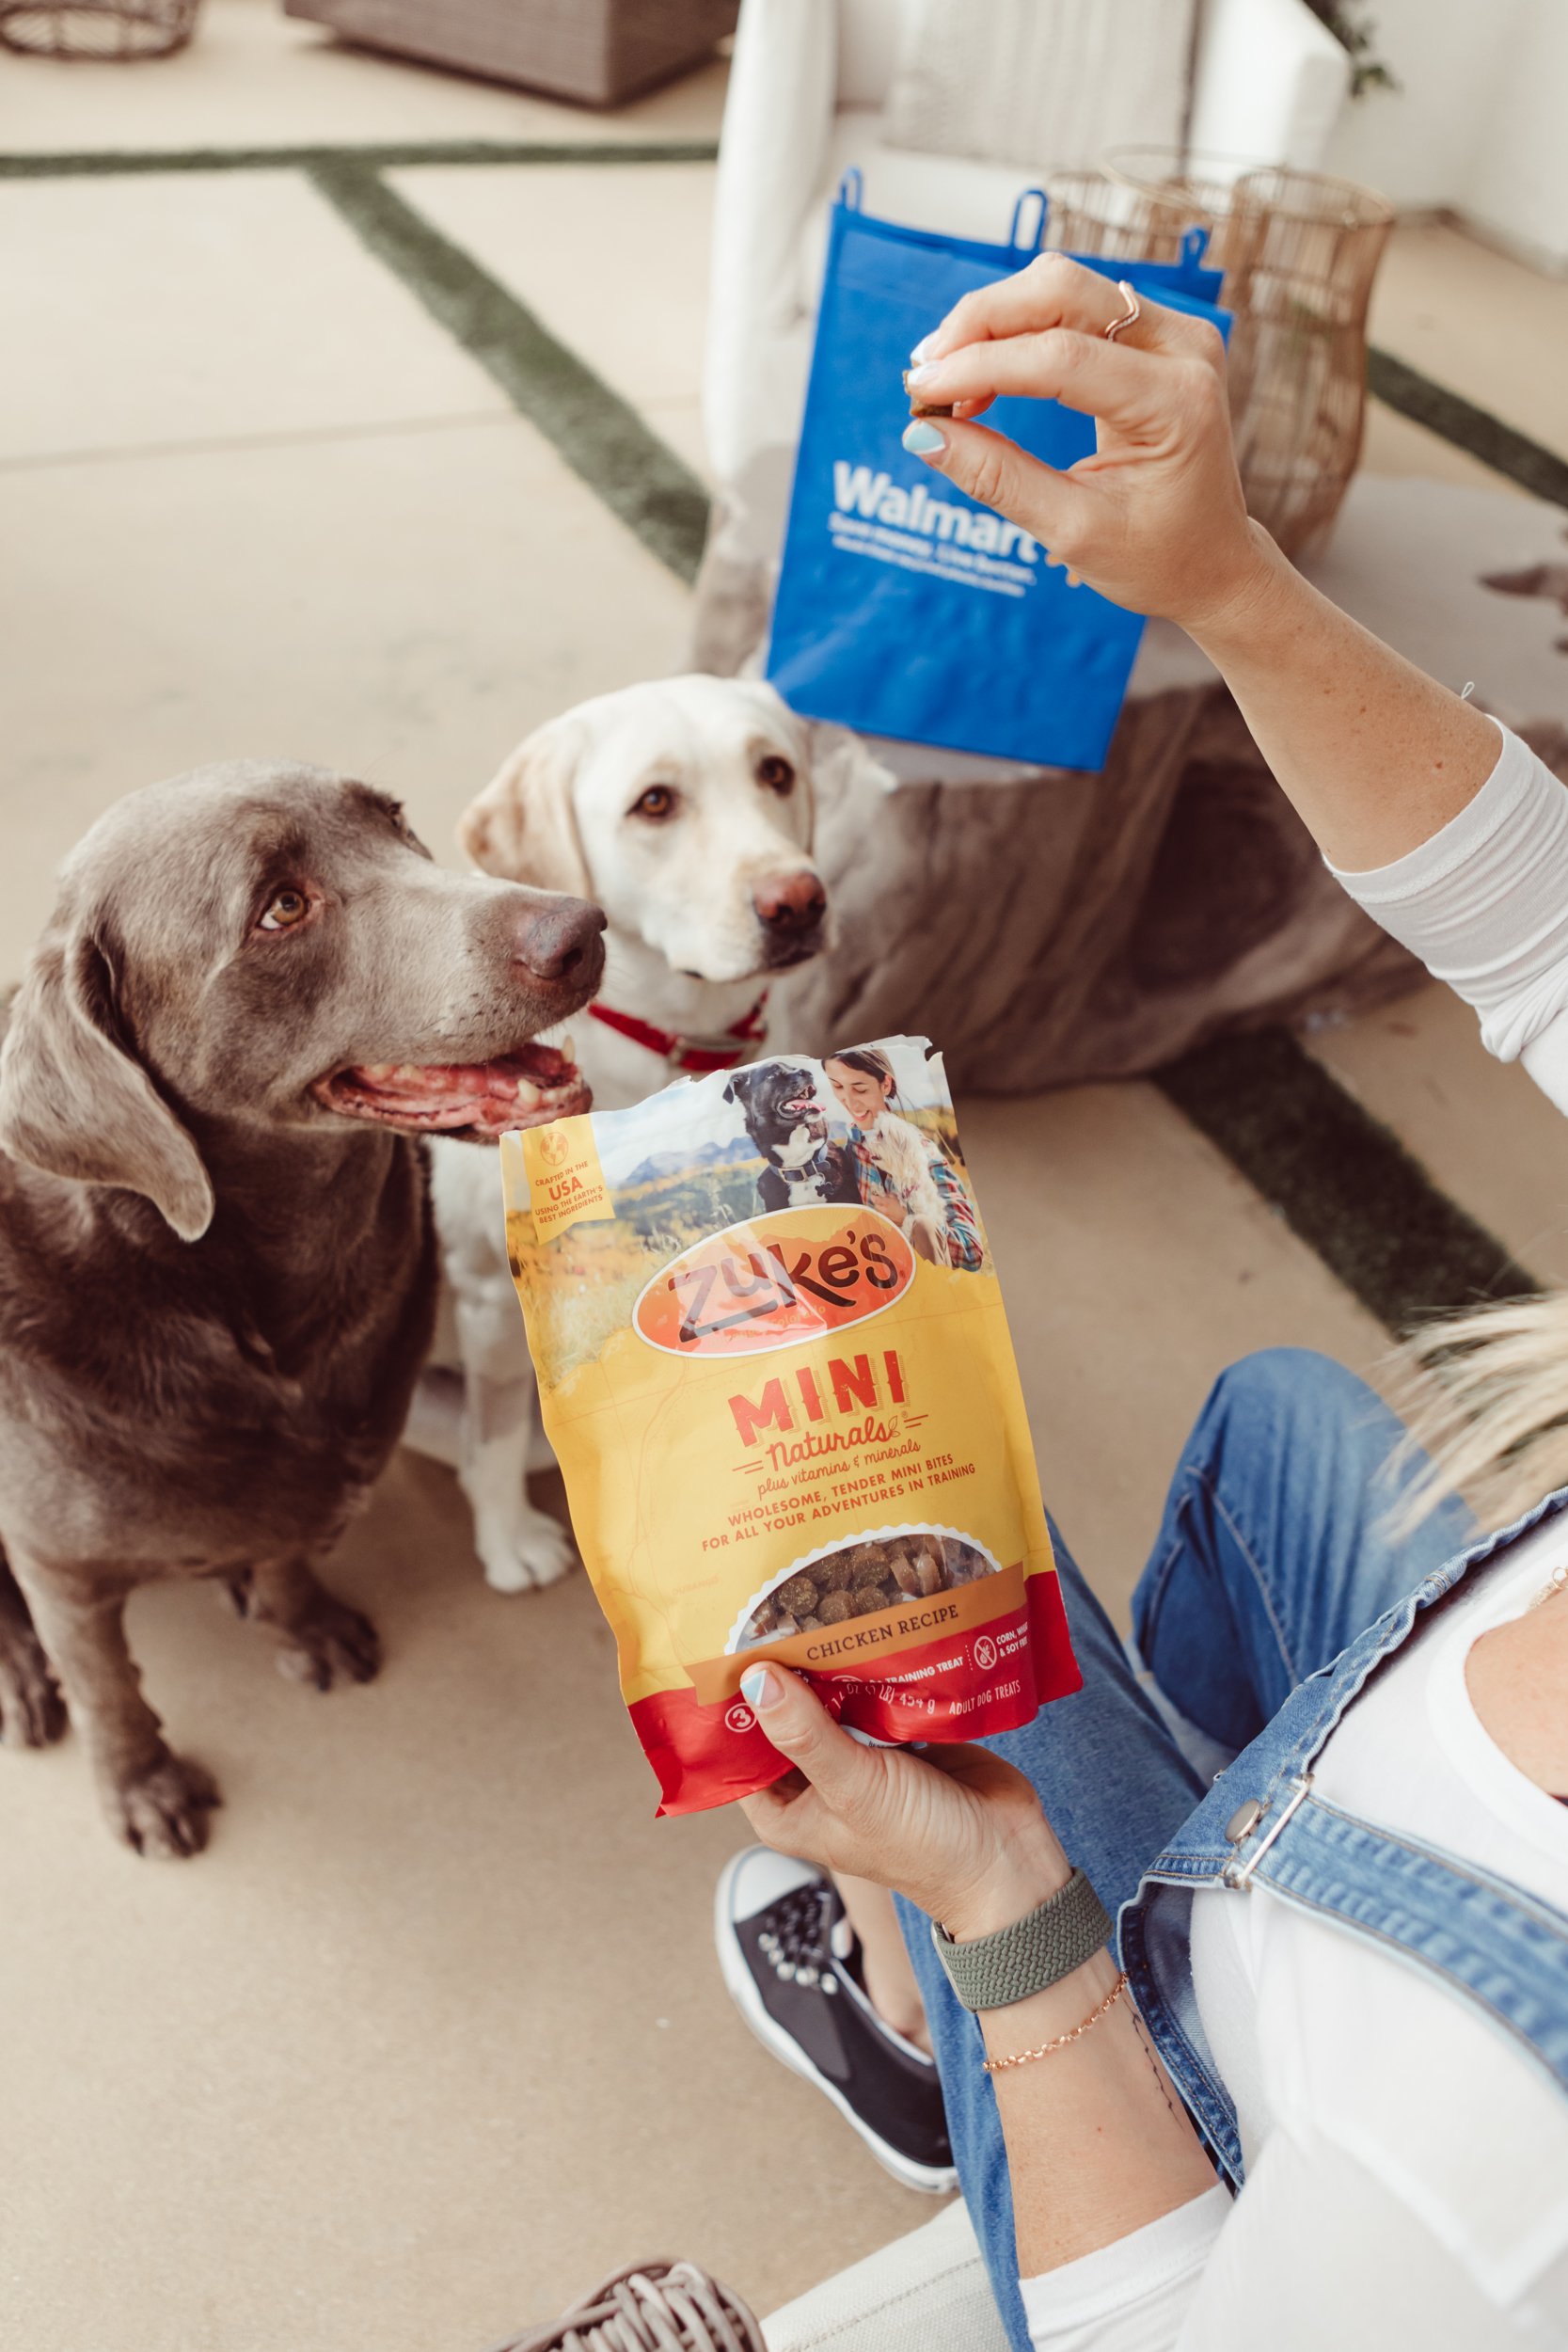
[[1242, 1786, 1568, 2091]]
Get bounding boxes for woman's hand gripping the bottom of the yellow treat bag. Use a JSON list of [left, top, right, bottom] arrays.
[[740, 1665, 1069, 1943]]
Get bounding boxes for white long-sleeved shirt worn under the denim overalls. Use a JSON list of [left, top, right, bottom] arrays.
[[1022, 734, 1568, 2352]]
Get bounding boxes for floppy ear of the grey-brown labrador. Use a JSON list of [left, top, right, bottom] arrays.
[[0, 934, 214, 1242]]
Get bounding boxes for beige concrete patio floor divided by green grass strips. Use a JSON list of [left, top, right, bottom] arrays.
[[0, 18, 1568, 2352]]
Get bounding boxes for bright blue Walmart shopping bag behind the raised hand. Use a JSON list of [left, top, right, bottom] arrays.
[[767, 185, 1229, 770]]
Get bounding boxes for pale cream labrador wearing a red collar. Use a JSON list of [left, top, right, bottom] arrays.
[[406, 677, 832, 1593]]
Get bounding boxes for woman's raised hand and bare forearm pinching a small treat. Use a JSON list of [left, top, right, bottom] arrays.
[[905, 254, 1497, 870]]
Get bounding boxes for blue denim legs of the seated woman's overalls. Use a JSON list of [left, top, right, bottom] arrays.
[[898, 1348, 1474, 2352]]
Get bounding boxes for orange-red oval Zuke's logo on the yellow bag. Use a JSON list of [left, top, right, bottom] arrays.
[[632, 1207, 914, 1355]]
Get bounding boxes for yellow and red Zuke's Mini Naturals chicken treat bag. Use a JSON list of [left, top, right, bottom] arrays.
[[500, 1038, 1079, 1814]]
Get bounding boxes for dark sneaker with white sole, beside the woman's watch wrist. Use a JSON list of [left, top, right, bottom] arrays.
[[712, 1847, 959, 2197]]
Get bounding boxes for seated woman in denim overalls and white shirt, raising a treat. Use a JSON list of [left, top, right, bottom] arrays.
[[719, 257, 1568, 2352]]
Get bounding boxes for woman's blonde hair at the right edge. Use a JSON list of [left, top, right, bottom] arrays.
[[1394, 1292, 1568, 1534]]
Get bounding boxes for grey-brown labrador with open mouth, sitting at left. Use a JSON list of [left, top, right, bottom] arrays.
[[0, 762, 602, 1853]]
